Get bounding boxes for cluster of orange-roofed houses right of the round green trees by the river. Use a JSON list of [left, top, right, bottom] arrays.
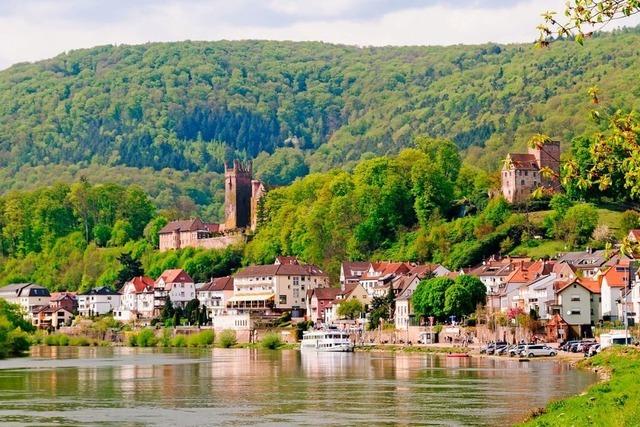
[[468, 246, 640, 339]]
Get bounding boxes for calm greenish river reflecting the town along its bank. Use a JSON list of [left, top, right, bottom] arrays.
[[0, 347, 597, 426]]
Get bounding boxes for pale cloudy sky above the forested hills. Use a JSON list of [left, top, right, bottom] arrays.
[[0, 0, 632, 69]]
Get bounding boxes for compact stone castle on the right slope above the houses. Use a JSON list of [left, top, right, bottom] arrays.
[[501, 141, 560, 203]]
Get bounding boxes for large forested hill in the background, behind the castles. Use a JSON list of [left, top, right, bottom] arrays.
[[0, 29, 640, 221]]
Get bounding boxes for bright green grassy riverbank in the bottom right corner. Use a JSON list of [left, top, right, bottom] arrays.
[[522, 347, 640, 427]]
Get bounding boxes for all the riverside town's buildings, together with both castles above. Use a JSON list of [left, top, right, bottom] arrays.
[[0, 141, 640, 352]]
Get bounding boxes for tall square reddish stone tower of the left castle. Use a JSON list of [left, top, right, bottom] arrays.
[[224, 160, 252, 230]]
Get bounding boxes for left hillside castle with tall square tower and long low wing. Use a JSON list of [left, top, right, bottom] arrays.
[[158, 160, 266, 251]]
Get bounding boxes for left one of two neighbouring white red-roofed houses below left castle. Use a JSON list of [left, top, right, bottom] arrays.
[[114, 276, 154, 322]]
